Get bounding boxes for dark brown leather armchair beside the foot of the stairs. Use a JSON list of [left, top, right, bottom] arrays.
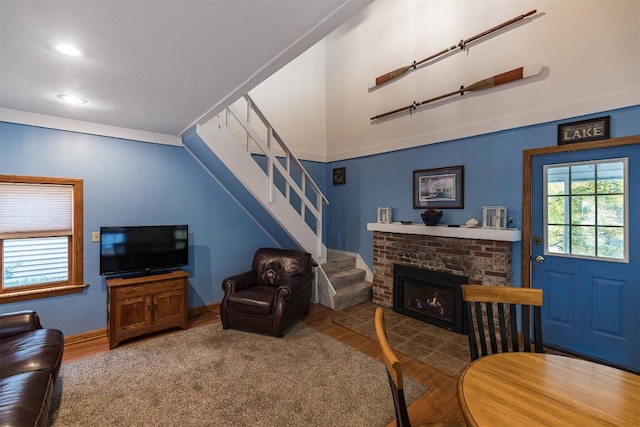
[[220, 248, 316, 337]]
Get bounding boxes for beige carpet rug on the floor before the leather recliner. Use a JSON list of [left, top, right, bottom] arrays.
[[51, 323, 427, 427]]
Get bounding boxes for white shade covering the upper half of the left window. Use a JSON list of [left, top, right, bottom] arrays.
[[0, 182, 73, 239]]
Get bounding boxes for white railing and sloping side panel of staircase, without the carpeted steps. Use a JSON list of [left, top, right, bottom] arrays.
[[192, 95, 328, 264]]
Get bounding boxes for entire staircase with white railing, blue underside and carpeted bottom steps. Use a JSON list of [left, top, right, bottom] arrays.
[[182, 95, 372, 310]]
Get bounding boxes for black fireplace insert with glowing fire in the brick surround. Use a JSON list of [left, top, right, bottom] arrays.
[[393, 264, 468, 334]]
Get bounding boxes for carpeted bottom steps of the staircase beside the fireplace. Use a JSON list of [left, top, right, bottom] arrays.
[[322, 250, 373, 311]]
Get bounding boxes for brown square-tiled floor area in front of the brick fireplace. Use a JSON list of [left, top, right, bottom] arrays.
[[332, 302, 470, 378]]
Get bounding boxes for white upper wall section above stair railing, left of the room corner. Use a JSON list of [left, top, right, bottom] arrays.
[[249, 40, 327, 161]]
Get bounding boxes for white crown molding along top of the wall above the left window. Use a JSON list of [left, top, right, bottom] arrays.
[[0, 108, 182, 147]]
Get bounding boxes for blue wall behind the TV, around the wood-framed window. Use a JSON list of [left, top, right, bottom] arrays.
[[0, 123, 277, 335]]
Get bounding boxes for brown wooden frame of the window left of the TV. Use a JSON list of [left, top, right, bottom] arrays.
[[0, 175, 88, 304]]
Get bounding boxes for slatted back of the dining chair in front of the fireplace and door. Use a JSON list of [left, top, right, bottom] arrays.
[[461, 285, 543, 360]]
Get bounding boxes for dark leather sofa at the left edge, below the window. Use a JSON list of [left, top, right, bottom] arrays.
[[0, 311, 64, 427]]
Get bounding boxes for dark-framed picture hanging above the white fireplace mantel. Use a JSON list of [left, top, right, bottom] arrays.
[[413, 166, 464, 209]]
